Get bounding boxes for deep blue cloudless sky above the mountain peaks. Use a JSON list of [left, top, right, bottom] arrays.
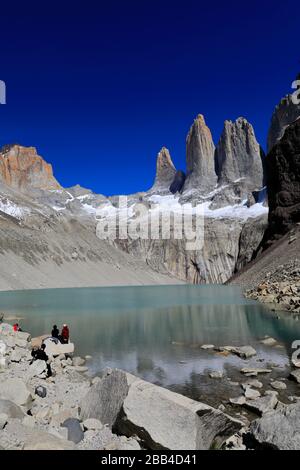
[[0, 0, 300, 195]]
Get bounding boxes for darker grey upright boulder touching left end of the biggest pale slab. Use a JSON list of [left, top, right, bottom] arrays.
[[80, 369, 128, 427]]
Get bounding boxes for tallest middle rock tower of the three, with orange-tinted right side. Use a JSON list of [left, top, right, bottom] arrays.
[[184, 114, 217, 193]]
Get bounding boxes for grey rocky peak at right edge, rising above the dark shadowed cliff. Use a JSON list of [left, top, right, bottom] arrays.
[[268, 74, 300, 152]]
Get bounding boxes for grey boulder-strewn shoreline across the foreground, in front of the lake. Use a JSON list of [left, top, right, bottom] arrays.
[[0, 323, 300, 450]]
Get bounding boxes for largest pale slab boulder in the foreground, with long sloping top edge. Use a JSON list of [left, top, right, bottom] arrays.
[[116, 374, 243, 450]]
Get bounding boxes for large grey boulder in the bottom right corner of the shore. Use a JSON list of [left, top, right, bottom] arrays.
[[249, 403, 300, 450]]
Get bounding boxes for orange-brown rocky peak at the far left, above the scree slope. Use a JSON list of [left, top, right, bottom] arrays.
[[0, 145, 60, 191]]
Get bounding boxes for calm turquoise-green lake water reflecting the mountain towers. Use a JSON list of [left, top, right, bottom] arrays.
[[0, 285, 300, 395]]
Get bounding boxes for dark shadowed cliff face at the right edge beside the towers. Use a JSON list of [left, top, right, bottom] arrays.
[[267, 119, 300, 236]]
